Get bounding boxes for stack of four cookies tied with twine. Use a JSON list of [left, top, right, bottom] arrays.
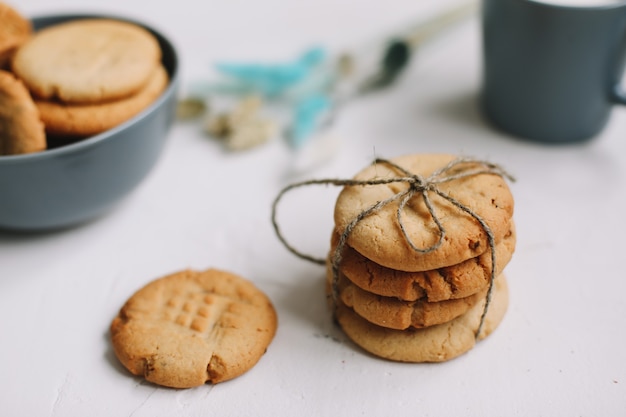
[[327, 155, 516, 362]]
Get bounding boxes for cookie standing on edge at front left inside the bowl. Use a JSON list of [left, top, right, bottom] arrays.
[[0, 70, 46, 155]]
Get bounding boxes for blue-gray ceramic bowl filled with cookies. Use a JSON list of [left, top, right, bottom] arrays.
[[0, 15, 180, 231]]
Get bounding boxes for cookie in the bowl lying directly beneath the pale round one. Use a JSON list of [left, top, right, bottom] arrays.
[[35, 66, 168, 137]]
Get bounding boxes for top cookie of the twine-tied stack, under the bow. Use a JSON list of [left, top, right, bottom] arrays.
[[334, 154, 513, 271]]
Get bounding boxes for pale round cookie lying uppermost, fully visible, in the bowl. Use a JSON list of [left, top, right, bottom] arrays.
[[12, 19, 161, 103]]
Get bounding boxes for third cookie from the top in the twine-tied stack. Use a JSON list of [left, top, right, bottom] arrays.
[[327, 270, 487, 330]]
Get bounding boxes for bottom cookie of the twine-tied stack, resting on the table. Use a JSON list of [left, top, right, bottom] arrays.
[[335, 276, 509, 362]]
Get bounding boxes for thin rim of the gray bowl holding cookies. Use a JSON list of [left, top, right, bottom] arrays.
[[0, 12, 180, 166]]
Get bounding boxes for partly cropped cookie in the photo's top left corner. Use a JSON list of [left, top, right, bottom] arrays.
[[0, 2, 33, 69]]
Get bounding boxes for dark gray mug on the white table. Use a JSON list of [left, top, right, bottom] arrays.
[[481, 0, 626, 143]]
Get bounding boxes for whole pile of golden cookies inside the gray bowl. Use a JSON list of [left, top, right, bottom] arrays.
[[0, 3, 169, 155]]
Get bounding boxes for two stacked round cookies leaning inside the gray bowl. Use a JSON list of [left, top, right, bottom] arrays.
[[12, 18, 168, 142]]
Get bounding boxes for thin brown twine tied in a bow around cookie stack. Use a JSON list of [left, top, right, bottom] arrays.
[[272, 157, 515, 337]]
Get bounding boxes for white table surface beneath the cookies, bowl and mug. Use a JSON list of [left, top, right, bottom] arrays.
[[0, 0, 626, 417]]
